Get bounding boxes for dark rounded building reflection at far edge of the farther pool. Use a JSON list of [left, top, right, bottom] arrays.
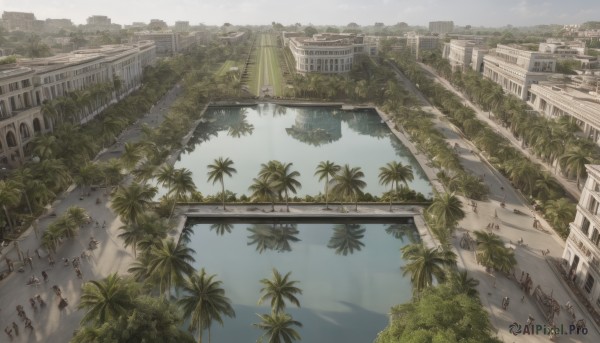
[[286, 106, 342, 146]]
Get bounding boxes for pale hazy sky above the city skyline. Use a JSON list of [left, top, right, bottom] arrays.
[[0, 0, 600, 27]]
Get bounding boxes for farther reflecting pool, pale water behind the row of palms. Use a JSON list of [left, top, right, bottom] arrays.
[[176, 104, 431, 196]]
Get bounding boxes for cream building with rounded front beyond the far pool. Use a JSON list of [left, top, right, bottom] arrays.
[[289, 33, 374, 74]]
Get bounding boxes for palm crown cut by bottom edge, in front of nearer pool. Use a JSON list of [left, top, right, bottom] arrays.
[[254, 313, 302, 343]]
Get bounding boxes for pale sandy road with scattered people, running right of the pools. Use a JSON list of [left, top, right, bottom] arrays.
[[386, 60, 600, 342]]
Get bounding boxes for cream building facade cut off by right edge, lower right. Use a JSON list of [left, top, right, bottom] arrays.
[[563, 165, 600, 311]]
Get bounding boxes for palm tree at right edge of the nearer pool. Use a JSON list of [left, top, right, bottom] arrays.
[[401, 244, 456, 294]]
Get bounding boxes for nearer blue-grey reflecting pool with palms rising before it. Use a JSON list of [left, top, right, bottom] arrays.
[[189, 223, 419, 343]]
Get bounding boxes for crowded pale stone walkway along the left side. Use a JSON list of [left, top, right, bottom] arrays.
[[0, 86, 181, 343]]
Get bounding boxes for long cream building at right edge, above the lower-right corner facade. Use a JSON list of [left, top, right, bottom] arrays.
[[527, 75, 600, 144]]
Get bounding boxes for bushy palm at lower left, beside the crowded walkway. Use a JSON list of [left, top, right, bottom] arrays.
[[77, 273, 138, 327]]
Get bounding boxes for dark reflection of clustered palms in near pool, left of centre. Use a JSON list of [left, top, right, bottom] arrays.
[[247, 223, 300, 254]]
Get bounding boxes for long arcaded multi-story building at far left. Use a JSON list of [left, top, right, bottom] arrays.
[[0, 41, 155, 166]]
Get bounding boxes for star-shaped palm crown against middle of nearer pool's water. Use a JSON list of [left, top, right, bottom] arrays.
[[258, 268, 302, 314]]
